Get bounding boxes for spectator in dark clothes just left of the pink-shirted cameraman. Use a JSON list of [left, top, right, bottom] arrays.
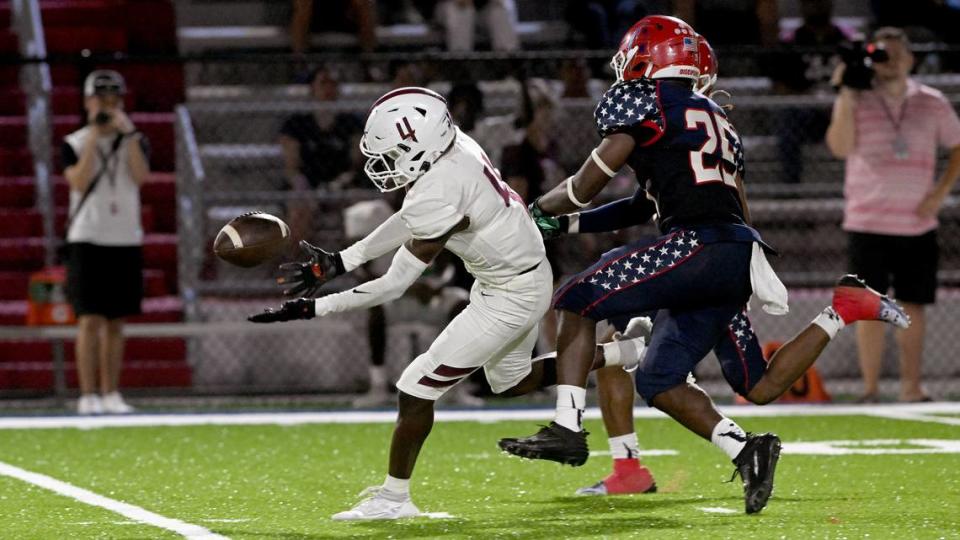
[[769, 0, 846, 183]]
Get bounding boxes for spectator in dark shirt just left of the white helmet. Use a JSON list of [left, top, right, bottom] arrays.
[[280, 67, 363, 245]]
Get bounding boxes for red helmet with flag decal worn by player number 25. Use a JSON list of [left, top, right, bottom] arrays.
[[610, 15, 700, 83]]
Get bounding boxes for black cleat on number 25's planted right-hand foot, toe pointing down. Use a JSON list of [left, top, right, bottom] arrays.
[[731, 433, 780, 514]]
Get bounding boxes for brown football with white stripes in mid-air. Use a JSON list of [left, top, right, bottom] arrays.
[[213, 212, 290, 268]]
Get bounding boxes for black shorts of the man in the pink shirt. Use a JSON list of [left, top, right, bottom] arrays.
[[847, 230, 940, 304]]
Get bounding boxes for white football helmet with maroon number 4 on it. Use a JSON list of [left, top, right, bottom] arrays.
[[360, 87, 456, 192]]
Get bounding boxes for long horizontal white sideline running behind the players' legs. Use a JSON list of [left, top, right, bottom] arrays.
[[0, 402, 960, 429]]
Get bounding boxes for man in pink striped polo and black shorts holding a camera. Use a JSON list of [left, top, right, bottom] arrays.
[[826, 27, 960, 402]]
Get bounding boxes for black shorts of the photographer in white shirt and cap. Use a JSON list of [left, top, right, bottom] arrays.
[[67, 242, 143, 319]]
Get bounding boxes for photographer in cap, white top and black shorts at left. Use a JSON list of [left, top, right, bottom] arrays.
[[61, 70, 150, 414]]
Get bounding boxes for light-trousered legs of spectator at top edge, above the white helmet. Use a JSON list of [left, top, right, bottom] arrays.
[[437, 0, 520, 52]]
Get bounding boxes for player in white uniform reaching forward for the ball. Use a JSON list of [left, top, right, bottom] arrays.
[[250, 88, 644, 520]]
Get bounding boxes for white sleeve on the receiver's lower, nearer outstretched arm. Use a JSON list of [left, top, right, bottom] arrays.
[[315, 246, 428, 317]]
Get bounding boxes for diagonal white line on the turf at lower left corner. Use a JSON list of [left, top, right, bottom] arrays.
[[0, 461, 229, 540]]
